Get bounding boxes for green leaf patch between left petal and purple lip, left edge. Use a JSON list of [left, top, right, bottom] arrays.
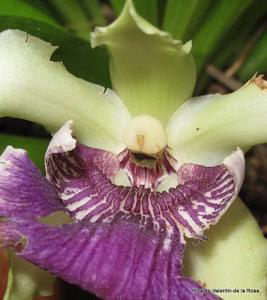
[[0, 134, 49, 171]]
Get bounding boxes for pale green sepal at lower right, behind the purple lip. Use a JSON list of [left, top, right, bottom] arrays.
[[184, 199, 267, 300]]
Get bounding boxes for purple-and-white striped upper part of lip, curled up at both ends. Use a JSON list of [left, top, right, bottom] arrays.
[[46, 122, 244, 238]]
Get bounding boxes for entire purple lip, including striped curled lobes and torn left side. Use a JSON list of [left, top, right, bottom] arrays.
[[0, 122, 244, 300]]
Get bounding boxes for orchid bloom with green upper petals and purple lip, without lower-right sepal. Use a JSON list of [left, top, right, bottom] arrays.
[[0, 1, 267, 300]]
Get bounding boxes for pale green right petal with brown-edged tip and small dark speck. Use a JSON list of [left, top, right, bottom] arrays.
[[167, 77, 267, 165]]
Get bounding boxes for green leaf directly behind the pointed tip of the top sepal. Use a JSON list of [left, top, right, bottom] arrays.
[[111, 0, 159, 26]]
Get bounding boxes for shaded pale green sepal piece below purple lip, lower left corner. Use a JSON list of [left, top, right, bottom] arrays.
[[3, 255, 55, 300]]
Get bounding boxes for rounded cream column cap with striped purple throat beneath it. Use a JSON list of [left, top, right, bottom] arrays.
[[119, 115, 174, 190]]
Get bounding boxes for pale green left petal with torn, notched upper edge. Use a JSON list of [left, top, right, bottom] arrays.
[[0, 30, 130, 152]]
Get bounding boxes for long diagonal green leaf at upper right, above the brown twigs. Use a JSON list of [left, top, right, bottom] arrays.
[[193, 0, 252, 70]]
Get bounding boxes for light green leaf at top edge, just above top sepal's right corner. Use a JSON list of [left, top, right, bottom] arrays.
[[163, 0, 214, 41]]
